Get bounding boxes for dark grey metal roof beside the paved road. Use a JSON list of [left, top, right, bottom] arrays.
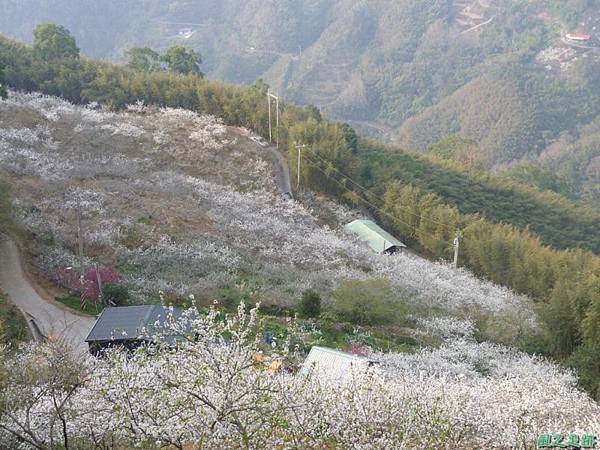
[[85, 305, 181, 342]]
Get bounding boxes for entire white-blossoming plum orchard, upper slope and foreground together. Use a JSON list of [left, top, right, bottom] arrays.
[[0, 92, 600, 448]]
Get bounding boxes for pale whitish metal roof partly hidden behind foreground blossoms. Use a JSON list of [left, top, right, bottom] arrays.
[[299, 347, 373, 378]]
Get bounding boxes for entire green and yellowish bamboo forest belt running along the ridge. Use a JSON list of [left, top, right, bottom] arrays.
[[0, 29, 600, 396]]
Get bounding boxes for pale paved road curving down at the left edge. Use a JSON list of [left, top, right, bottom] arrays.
[[0, 236, 95, 351]]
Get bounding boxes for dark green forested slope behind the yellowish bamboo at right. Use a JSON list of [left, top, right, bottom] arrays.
[[357, 144, 600, 253]]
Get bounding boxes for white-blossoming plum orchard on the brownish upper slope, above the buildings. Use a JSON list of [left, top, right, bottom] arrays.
[[0, 92, 529, 315]]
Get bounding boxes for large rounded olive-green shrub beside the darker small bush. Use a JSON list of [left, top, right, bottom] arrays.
[[333, 280, 398, 325]]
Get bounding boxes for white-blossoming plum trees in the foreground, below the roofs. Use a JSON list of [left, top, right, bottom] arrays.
[[0, 305, 600, 449]]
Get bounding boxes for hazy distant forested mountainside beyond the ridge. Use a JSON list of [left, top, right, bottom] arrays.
[[0, 0, 600, 200]]
